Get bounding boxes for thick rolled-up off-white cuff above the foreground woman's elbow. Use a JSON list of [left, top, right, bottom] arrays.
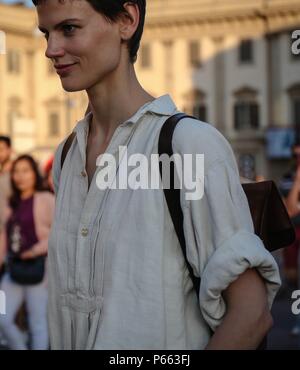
[[199, 230, 281, 331]]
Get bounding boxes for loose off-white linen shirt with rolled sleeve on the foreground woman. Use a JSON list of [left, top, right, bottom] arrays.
[[49, 95, 280, 350]]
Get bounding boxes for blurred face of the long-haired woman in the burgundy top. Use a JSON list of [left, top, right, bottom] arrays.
[[12, 160, 36, 193]]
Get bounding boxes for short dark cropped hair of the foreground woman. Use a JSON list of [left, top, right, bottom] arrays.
[[32, 0, 146, 63]]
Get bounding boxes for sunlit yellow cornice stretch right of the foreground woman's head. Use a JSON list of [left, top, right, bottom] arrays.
[[146, 0, 300, 30]]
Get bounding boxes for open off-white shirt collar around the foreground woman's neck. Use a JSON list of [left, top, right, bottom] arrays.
[[73, 94, 177, 132]]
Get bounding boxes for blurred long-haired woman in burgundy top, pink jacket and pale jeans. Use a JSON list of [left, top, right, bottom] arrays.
[[0, 155, 54, 350]]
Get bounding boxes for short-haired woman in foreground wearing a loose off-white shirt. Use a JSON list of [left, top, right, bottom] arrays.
[[34, 0, 280, 350]]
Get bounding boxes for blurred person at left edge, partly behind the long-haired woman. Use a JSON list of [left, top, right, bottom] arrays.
[[0, 135, 12, 231]]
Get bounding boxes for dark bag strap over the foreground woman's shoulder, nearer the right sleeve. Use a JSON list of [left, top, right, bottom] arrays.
[[158, 113, 200, 297]]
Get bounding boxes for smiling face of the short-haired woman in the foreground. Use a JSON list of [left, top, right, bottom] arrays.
[[37, 0, 121, 91]]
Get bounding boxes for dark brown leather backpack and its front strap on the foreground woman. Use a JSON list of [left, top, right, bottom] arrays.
[[158, 113, 296, 272]]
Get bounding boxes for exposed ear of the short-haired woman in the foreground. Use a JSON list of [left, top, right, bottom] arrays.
[[118, 2, 140, 41]]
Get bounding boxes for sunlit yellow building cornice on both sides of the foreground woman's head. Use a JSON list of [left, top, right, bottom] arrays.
[[0, 0, 300, 37]]
